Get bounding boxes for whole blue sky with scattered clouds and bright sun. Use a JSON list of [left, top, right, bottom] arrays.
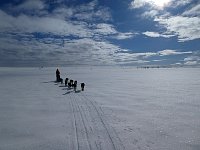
[[0, 0, 200, 66]]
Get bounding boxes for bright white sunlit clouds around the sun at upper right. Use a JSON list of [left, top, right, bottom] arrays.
[[131, 0, 200, 42]]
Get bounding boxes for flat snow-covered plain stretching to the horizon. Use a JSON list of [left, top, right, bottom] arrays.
[[0, 67, 200, 150]]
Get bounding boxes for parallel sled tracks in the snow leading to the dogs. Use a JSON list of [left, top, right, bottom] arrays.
[[68, 93, 125, 150]]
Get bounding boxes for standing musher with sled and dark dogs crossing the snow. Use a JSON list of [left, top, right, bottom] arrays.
[[56, 69, 85, 91]]
